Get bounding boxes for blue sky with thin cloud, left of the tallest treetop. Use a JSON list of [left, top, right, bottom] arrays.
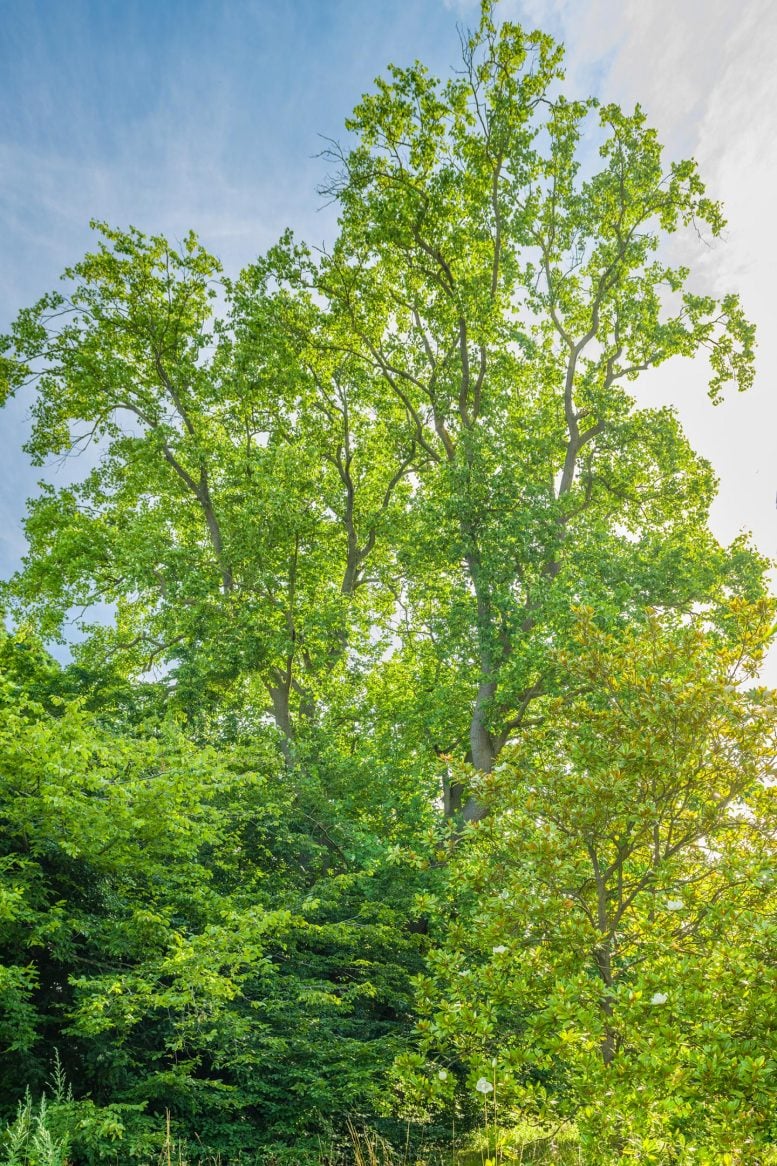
[[0, 0, 456, 310]]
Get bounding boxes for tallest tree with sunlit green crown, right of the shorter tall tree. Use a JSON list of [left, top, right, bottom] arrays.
[[310, 3, 753, 819]]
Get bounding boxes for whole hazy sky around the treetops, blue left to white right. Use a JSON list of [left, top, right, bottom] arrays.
[[0, 0, 777, 666]]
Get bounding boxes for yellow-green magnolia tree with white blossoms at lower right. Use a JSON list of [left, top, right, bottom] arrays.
[[405, 604, 777, 1163]]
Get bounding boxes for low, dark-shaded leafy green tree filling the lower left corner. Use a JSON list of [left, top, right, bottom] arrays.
[[0, 637, 420, 1166]]
